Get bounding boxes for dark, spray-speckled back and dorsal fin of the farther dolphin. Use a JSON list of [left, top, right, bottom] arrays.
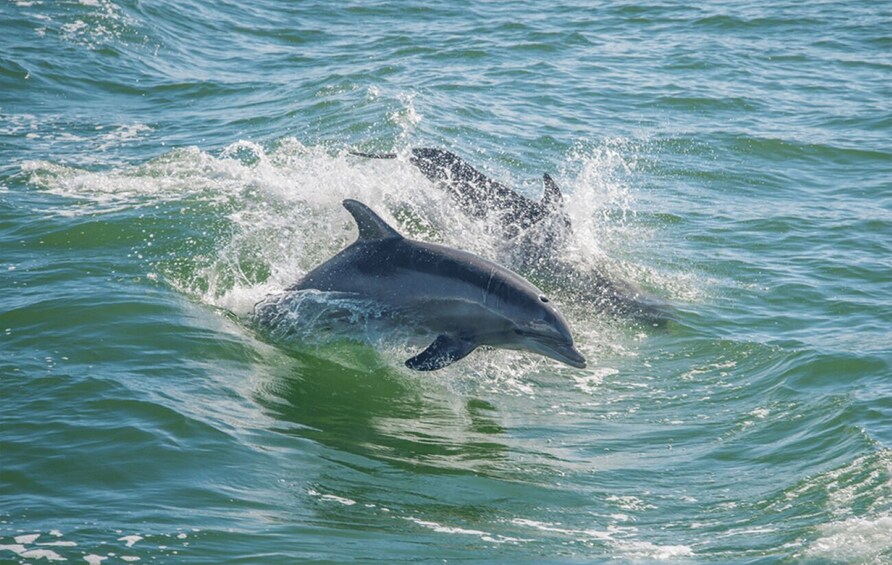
[[351, 147, 570, 238]]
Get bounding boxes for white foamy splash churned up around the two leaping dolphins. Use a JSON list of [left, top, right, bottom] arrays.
[[22, 138, 684, 374]]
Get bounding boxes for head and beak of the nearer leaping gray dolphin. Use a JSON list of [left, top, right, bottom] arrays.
[[506, 294, 585, 369]]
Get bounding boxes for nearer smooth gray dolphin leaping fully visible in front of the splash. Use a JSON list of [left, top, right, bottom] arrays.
[[288, 200, 585, 371]]
